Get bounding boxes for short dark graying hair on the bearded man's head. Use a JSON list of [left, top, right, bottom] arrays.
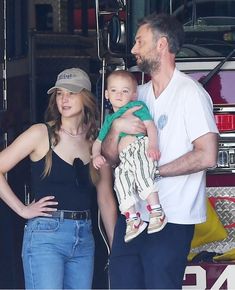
[[138, 13, 184, 54]]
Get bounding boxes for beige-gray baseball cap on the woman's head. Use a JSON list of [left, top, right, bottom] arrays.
[[47, 68, 91, 94]]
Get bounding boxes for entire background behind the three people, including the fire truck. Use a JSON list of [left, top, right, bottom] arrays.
[[0, 0, 235, 289]]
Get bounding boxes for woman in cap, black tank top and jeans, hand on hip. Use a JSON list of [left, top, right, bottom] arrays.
[[0, 68, 116, 289]]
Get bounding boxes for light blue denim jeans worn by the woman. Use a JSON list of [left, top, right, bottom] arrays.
[[22, 217, 95, 289]]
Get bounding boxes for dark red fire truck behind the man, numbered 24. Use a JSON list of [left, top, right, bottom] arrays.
[[96, 0, 235, 289]]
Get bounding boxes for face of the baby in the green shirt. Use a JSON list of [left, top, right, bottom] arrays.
[[105, 76, 136, 111]]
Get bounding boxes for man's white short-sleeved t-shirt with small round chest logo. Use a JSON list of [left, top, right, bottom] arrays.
[[138, 69, 218, 224]]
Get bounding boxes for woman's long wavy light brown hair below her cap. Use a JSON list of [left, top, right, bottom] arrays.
[[43, 89, 99, 184]]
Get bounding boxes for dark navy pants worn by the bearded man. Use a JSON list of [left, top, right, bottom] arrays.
[[109, 215, 194, 289]]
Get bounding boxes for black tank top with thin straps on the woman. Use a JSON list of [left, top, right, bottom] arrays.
[[31, 123, 95, 210]]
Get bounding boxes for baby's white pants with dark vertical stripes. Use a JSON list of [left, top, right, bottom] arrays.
[[114, 136, 158, 213]]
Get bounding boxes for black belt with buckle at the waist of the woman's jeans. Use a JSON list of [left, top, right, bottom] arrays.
[[49, 210, 91, 220]]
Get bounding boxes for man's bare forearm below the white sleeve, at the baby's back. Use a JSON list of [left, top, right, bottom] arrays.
[[158, 133, 218, 177]]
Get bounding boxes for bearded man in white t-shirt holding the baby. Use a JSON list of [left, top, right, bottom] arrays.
[[103, 14, 218, 289]]
